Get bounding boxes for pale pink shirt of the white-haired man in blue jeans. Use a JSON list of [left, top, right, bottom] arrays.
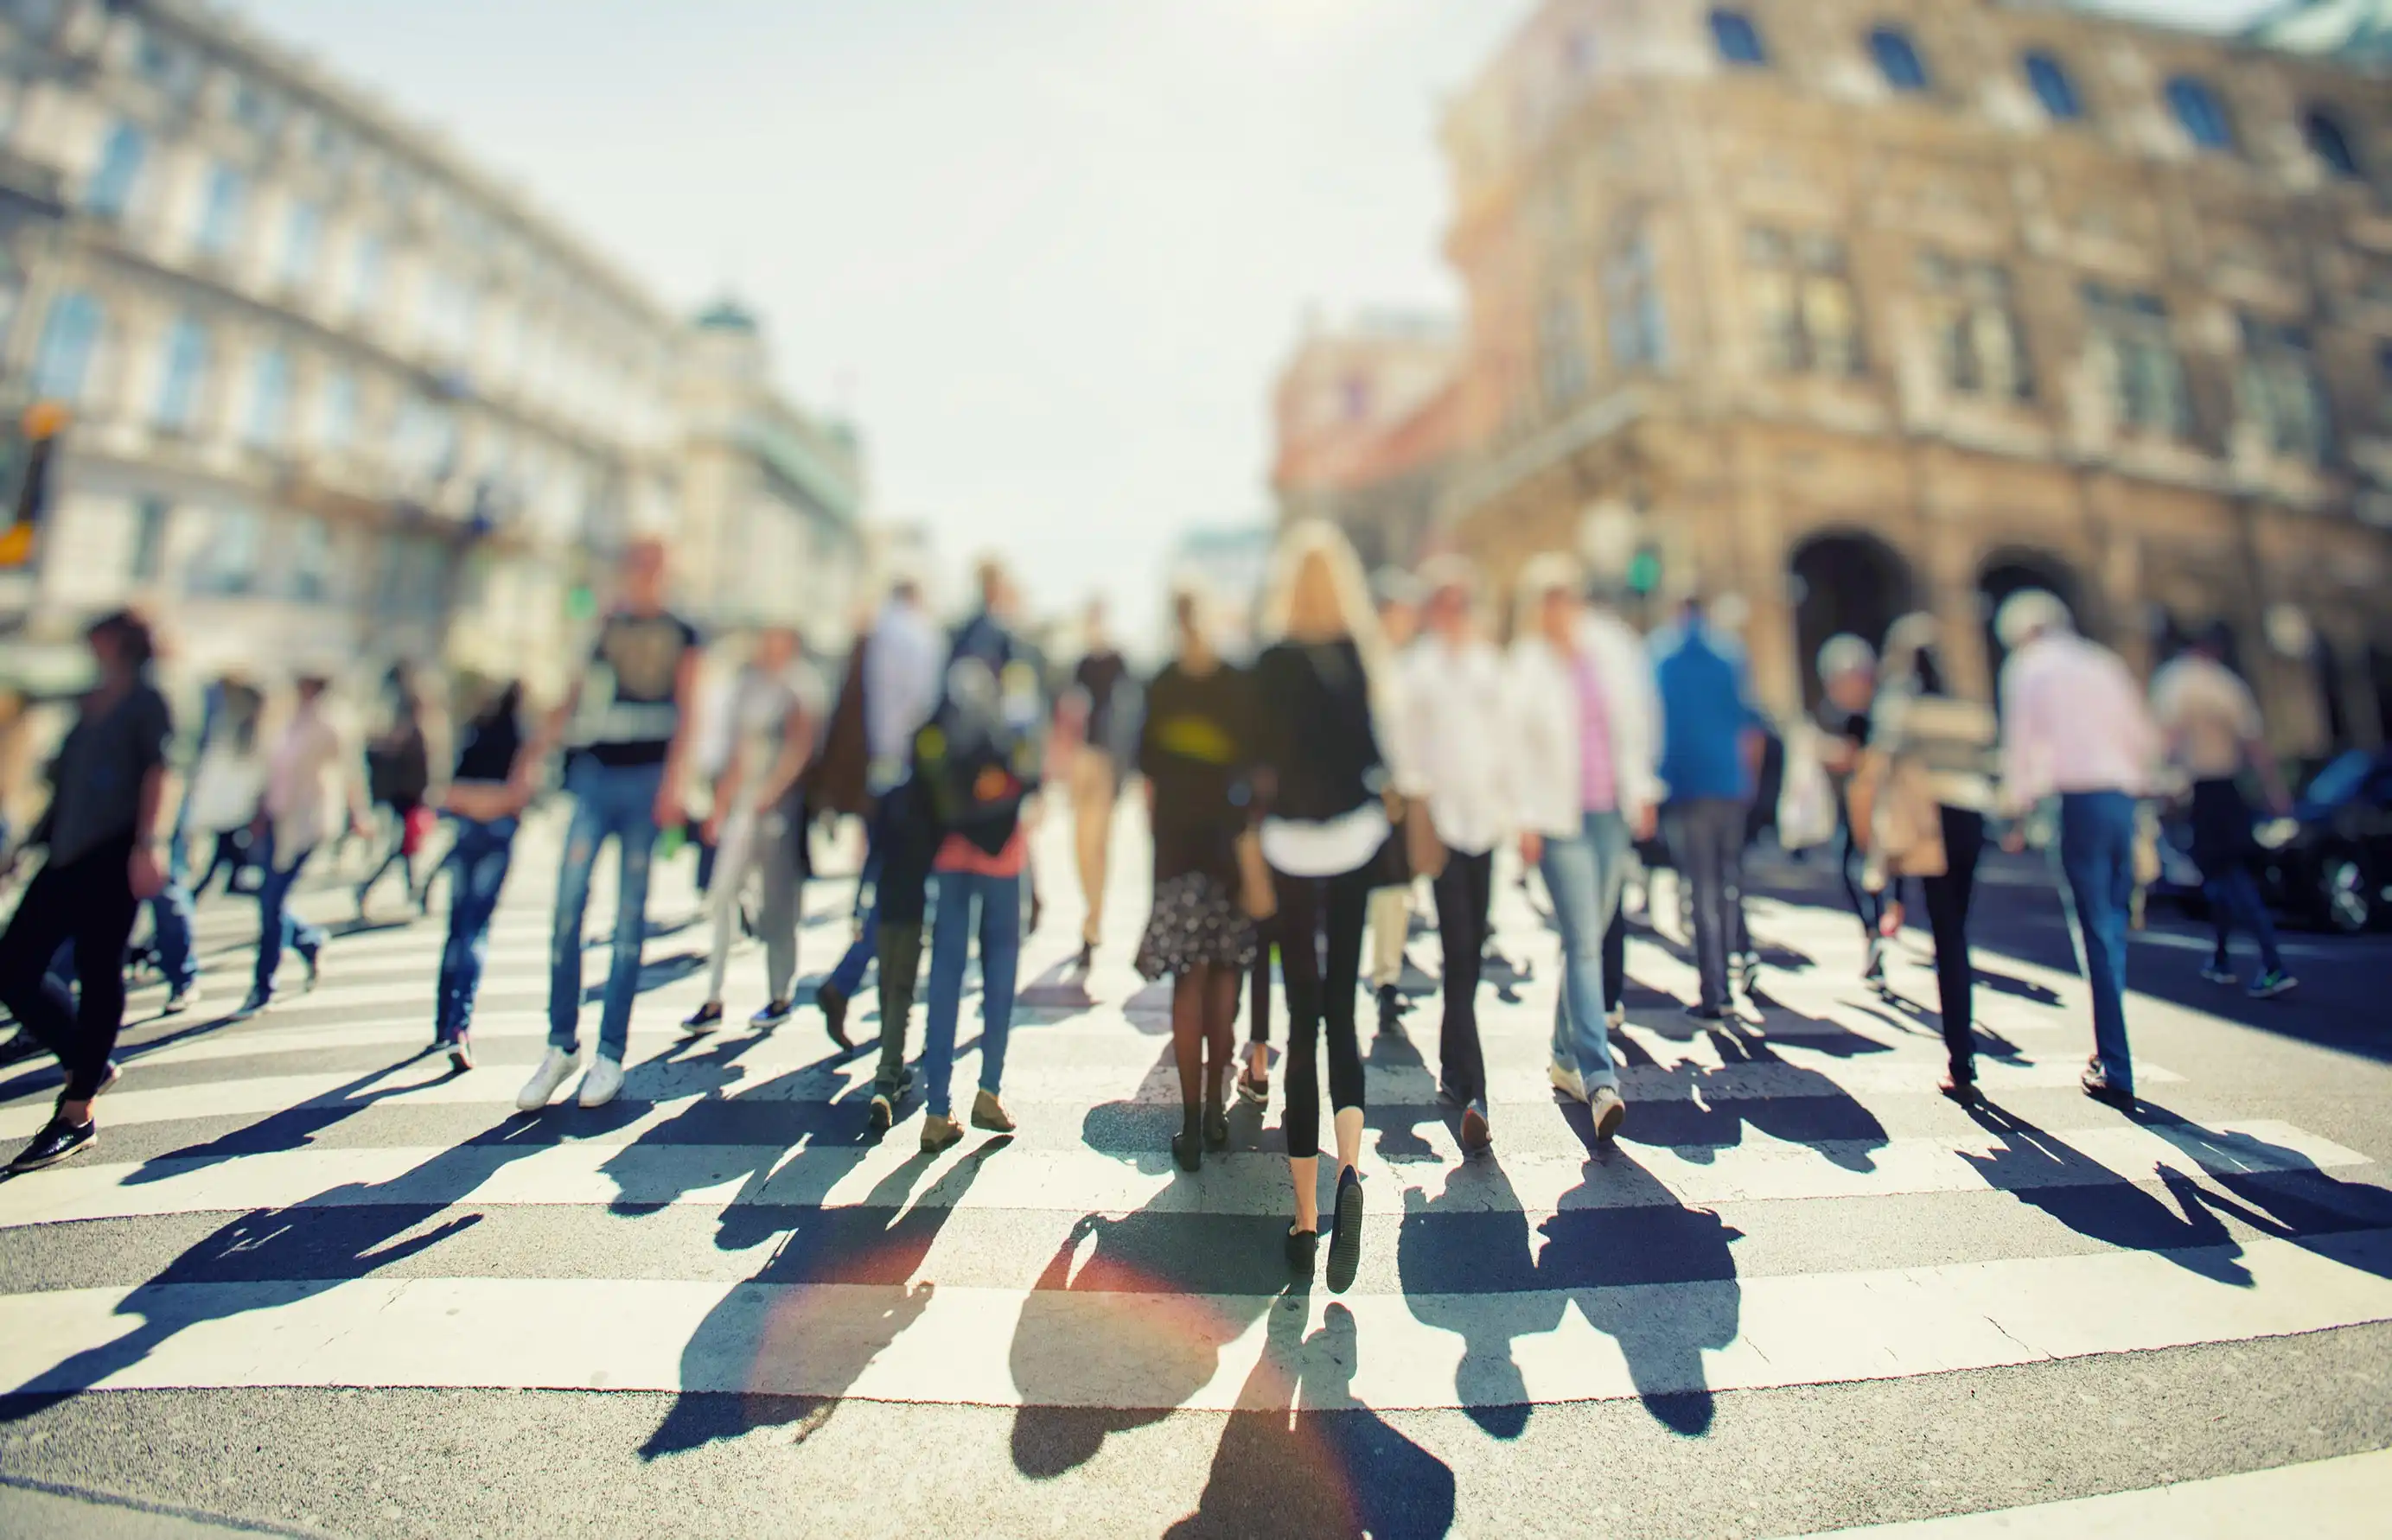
[[2002, 632, 2160, 806]]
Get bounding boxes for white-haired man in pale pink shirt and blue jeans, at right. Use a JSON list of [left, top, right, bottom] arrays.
[[1995, 590, 2160, 1104]]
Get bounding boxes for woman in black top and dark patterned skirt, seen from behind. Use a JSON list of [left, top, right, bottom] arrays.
[[1139, 593, 1256, 1172]]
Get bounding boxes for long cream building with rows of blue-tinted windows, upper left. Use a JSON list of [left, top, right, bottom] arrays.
[[0, 0, 682, 686]]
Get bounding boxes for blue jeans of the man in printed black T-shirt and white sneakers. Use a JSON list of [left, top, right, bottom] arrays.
[[548, 760, 665, 1064]]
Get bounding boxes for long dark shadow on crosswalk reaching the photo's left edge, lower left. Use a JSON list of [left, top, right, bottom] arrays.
[[0, 1119, 552, 1422]]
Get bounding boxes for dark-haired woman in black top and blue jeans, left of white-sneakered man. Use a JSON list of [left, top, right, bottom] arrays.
[[440, 684, 526, 1072]]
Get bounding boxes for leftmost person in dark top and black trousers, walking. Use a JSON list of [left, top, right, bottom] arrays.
[[0, 612, 175, 1172]]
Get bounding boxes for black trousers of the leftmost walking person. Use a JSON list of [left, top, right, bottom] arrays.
[[0, 835, 141, 1103]]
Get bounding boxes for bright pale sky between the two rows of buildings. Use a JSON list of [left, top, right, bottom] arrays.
[[237, 0, 2254, 629]]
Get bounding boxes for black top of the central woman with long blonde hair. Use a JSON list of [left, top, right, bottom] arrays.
[[1253, 639, 1387, 823]]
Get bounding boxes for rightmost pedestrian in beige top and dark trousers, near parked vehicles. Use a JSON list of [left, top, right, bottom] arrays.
[[2151, 629, 2299, 1000]]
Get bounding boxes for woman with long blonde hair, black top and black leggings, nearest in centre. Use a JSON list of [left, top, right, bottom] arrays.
[[1253, 524, 1392, 1291]]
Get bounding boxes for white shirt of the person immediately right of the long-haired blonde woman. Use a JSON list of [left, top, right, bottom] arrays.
[[1392, 633, 1512, 856]]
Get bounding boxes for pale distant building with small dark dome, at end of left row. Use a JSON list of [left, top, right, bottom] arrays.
[[674, 302, 866, 651]]
